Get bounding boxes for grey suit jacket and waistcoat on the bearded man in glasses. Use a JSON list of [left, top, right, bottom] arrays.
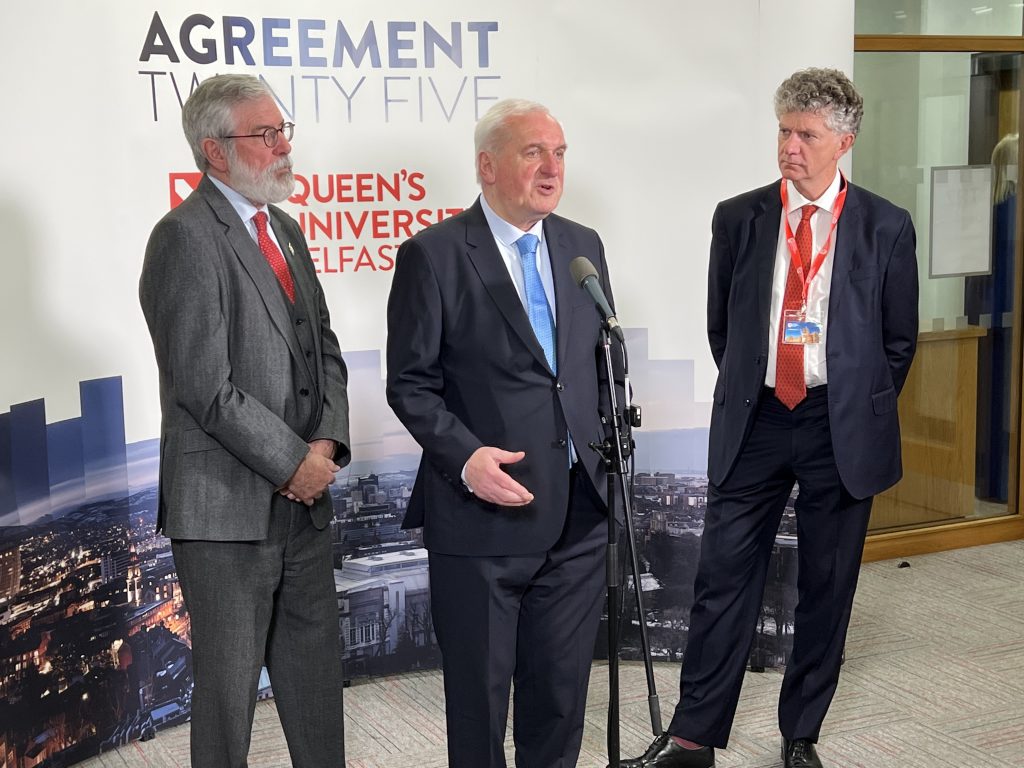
[[139, 176, 350, 541]]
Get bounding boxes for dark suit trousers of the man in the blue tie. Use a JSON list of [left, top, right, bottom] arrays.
[[430, 472, 608, 768]]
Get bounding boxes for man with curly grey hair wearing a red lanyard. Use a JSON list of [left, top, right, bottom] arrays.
[[622, 69, 918, 768]]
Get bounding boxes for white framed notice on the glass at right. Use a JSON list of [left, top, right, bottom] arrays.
[[928, 165, 992, 278]]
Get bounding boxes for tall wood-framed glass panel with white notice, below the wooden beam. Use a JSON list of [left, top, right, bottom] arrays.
[[852, 53, 1021, 531]]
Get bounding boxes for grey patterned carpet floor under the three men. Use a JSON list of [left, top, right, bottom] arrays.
[[81, 542, 1024, 768]]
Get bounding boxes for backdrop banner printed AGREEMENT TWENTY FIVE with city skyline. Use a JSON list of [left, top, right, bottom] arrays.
[[0, 0, 853, 768]]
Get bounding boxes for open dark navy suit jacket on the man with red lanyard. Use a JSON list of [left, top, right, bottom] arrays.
[[708, 181, 918, 499]]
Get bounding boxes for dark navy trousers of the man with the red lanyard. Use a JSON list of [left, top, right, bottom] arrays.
[[669, 387, 871, 748]]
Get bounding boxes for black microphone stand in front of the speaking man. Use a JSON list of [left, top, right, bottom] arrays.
[[590, 322, 662, 768]]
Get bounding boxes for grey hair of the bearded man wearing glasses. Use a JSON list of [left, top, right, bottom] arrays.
[[181, 75, 273, 171]]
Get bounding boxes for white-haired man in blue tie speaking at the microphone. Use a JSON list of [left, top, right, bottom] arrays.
[[387, 100, 611, 768]]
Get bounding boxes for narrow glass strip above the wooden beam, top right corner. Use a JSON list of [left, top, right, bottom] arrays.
[[854, 0, 1024, 35]]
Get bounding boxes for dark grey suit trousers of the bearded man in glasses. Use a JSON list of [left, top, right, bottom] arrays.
[[171, 496, 345, 768]]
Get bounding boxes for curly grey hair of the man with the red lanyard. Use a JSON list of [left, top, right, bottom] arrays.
[[775, 68, 864, 136]]
